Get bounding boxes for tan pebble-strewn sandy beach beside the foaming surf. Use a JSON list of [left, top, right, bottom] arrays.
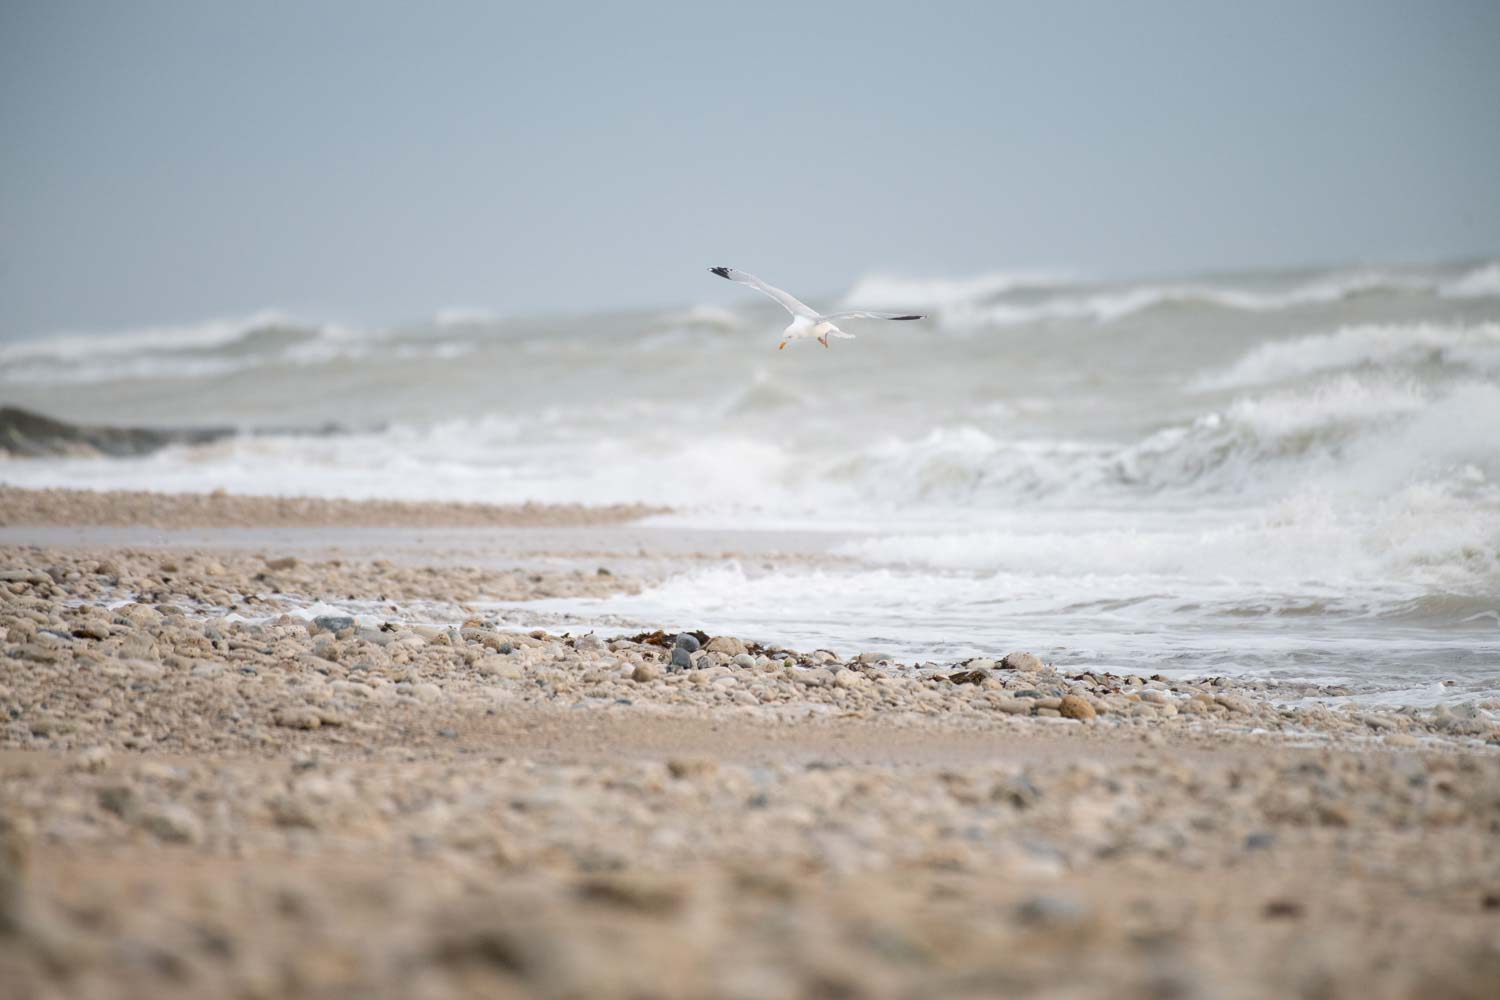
[[0, 489, 1500, 999]]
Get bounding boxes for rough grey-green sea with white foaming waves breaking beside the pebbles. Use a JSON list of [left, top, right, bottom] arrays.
[[0, 261, 1500, 700]]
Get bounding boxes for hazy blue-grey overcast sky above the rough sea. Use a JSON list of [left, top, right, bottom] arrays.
[[0, 0, 1500, 336]]
